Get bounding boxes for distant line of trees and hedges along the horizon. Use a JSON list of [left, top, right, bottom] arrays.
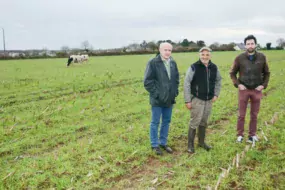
[[0, 38, 285, 59]]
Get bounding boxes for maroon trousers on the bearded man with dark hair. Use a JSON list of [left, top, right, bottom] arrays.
[[237, 89, 262, 137]]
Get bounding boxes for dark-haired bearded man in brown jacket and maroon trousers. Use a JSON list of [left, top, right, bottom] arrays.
[[230, 35, 270, 143]]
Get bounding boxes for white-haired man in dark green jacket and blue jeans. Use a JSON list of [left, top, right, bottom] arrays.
[[144, 43, 179, 155]]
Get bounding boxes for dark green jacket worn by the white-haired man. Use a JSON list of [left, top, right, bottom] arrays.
[[144, 55, 179, 107]]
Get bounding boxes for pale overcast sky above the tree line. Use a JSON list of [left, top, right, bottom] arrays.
[[0, 0, 285, 49]]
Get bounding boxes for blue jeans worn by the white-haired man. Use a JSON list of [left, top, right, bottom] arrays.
[[150, 106, 173, 147]]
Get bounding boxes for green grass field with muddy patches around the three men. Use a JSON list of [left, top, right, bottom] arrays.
[[0, 51, 285, 189]]
